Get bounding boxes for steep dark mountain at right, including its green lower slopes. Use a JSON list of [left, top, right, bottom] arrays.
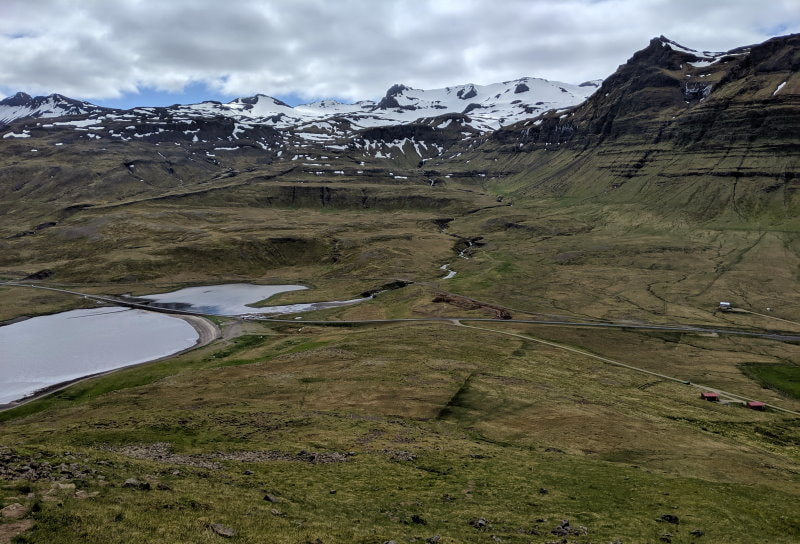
[[481, 35, 800, 221]]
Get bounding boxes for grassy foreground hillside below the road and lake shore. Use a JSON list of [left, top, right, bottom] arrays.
[[0, 314, 800, 543]]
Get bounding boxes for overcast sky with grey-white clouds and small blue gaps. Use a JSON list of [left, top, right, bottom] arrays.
[[0, 0, 800, 107]]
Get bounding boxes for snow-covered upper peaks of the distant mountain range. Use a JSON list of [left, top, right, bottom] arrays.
[[0, 78, 600, 131]]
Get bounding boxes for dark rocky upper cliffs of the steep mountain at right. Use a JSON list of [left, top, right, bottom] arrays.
[[495, 35, 800, 152]]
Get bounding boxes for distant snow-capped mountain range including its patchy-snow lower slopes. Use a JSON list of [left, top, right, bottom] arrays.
[[0, 78, 601, 161]]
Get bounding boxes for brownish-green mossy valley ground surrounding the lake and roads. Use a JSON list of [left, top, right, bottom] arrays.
[[0, 176, 800, 543]]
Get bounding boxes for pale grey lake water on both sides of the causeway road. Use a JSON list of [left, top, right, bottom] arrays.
[[0, 283, 370, 404]]
